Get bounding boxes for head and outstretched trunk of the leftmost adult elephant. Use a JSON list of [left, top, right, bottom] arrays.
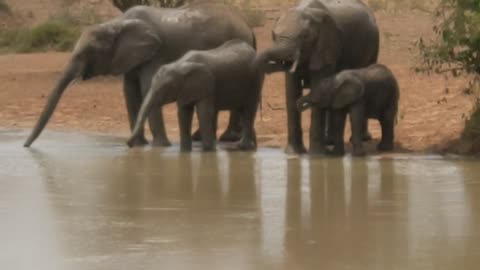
[[24, 18, 162, 147]]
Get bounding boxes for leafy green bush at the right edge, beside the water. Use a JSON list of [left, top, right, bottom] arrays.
[[417, 0, 480, 144]]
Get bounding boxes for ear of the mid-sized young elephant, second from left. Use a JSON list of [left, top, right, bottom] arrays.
[[177, 62, 215, 106]]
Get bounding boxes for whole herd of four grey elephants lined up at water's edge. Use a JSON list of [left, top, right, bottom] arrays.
[[25, 0, 399, 156]]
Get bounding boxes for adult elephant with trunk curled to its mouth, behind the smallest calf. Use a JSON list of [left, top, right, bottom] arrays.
[[256, 0, 379, 153]]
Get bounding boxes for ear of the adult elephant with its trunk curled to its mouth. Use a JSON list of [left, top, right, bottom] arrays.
[[305, 8, 342, 73]]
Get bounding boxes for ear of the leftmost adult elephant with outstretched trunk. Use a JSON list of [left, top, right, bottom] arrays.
[[110, 19, 162, 75]]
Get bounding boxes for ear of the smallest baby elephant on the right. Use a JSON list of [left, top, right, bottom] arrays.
[[332, 75, 365, 109]]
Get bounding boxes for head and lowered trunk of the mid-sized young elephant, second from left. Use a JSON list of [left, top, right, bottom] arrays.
[[127, 60, 214, 147]]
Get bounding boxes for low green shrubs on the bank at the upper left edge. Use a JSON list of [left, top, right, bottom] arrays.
[[0, 18, 81, 52]]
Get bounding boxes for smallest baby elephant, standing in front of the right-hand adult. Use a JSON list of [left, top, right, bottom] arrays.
[[297, 64, 399, 156]]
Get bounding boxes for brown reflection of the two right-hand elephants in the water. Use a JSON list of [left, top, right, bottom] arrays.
[[285, 159, 408, 269]]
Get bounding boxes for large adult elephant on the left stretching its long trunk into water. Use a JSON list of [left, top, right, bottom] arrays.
[[25, 3, 255, 147]]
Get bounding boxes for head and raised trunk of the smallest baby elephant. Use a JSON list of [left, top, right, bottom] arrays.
[[297, 74, 365, 111]]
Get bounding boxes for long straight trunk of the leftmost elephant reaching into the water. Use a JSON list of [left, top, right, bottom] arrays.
[[24, 62, 78, 147]]
